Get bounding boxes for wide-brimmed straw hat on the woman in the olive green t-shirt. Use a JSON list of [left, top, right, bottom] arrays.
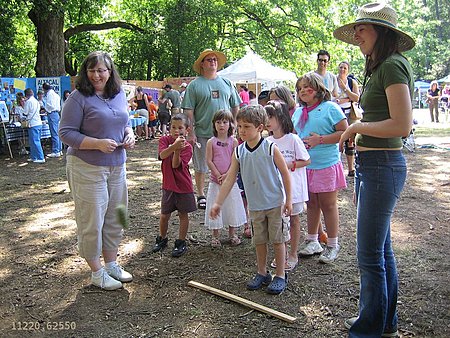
[[333, 2, 416, 52]]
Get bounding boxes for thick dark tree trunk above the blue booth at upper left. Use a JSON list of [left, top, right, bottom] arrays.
[[28, 9, 66, 77]]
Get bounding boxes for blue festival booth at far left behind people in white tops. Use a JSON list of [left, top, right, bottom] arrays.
[[0, 76, 71, 158]]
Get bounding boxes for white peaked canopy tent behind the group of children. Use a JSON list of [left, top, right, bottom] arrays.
[[218, 51, 297, 96]]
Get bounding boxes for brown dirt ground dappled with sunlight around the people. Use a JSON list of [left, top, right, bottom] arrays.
[[0, 131, 450, 337]]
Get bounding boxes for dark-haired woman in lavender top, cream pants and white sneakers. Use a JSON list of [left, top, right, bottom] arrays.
[[59, 52, 135, 290]]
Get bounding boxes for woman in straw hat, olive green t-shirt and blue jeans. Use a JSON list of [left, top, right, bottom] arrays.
[[334, 3, 415, 337]]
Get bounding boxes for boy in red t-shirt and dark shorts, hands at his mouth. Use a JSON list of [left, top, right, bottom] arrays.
[[153, 114, 197, 257]]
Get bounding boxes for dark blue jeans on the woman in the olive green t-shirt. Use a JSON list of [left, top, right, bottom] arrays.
[[349, 150, 406, 337]]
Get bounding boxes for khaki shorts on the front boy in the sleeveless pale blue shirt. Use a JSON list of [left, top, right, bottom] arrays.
[[250, 206, 286, 245]]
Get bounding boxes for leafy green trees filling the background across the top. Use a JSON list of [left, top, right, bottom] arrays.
[[0, 0, 450, 80]]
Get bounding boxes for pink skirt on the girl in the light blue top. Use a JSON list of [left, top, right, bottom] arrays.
[[306, 162, 347, 194]]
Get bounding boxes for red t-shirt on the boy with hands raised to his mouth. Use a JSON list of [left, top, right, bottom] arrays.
[[158, 136, 194, 194]]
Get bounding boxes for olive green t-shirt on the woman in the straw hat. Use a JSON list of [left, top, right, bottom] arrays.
[[356, 54, 414, 148]]
